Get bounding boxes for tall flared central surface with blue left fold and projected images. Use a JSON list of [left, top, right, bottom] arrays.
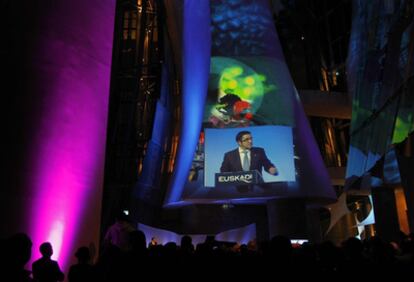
[[165, 0, 336, 205]]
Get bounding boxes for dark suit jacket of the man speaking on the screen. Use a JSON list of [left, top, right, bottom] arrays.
[[220, 147, 275, 173]]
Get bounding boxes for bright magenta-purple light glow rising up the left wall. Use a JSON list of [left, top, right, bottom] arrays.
[[26, 0, 115, 269]]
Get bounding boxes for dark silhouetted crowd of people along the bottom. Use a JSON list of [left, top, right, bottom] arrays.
[[1, 216, 414, 282]]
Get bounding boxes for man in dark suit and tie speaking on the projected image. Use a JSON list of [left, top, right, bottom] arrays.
[[220, 131, 278, 175]]
